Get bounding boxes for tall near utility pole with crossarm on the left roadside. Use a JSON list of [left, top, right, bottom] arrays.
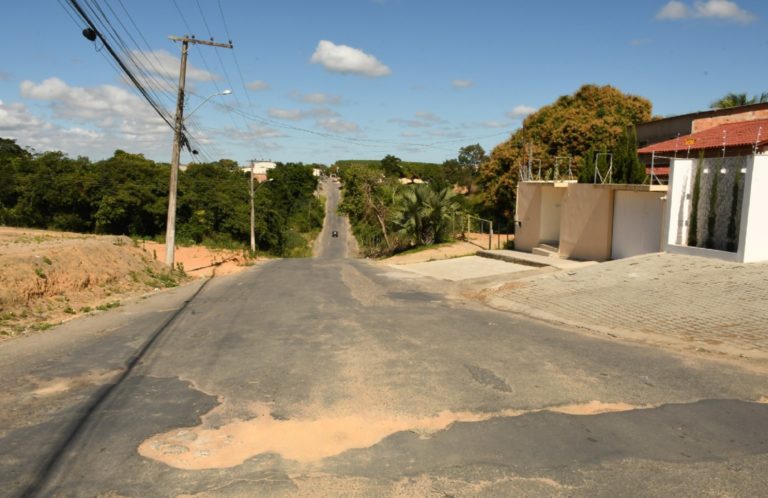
[[165, 36, 232, 269]]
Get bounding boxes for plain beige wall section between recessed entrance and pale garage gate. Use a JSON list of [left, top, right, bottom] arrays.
[[560, 184, 614, 261]]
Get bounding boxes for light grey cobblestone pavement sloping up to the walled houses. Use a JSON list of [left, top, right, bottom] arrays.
[[486, 254, 768, 359]]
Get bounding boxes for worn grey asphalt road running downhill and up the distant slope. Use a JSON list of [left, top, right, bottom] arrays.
[[0, 181, 768, 497]]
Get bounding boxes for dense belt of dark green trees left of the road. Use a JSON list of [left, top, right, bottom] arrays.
[[0, 138, 324, 256]]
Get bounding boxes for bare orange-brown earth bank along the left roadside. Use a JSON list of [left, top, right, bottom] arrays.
[[0, 227, 253, 340]]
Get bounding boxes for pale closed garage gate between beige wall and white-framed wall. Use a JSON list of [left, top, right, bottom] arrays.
[[611, 190, 665, 259]]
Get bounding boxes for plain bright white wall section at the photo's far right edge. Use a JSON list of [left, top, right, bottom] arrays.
[[739, 155, 768, 263]]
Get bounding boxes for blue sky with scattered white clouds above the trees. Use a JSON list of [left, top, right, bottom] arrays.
[[0, 0, 768, 164]]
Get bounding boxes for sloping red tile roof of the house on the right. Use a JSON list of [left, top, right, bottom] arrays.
[[637, 119, 768, 154]]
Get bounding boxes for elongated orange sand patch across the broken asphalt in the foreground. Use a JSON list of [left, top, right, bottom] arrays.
[[138, 401, 651, 470]]
